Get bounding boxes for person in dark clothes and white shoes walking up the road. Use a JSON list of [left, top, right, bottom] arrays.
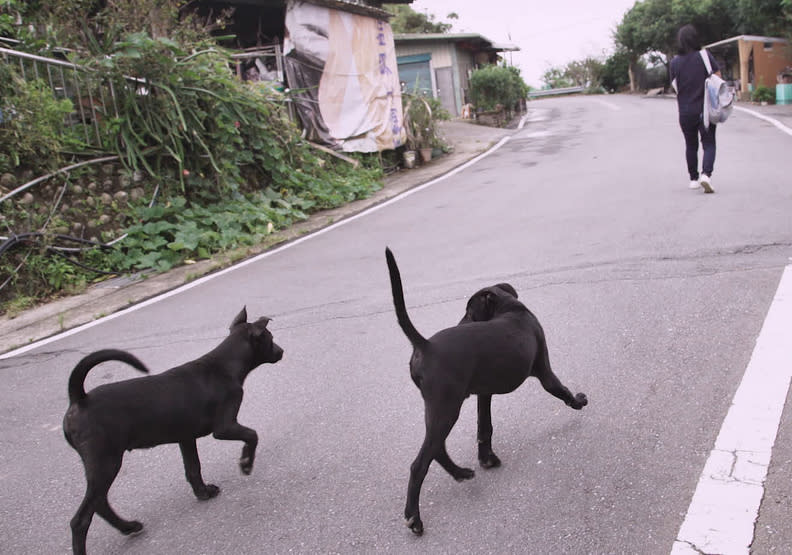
[[671, 25, 720, 193]]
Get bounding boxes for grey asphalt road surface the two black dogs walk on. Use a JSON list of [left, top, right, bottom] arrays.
[[0, 97, 792, 554]]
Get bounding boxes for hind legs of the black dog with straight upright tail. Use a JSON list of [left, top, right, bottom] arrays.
[[404, 400, 473, 536]]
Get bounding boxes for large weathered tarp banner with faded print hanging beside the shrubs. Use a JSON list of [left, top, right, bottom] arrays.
[[284, 0, 406, 152]]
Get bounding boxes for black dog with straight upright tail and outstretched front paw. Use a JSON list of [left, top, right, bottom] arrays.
[[385, 248, 588, 535]]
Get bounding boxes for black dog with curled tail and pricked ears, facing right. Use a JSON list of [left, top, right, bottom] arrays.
[[63, 308, 283, 554]]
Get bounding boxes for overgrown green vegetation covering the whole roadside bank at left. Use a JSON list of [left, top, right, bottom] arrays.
[[0, 6, 383, 314]]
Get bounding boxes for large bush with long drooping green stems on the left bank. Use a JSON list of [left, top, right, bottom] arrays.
[[76, 33, 318, 199]]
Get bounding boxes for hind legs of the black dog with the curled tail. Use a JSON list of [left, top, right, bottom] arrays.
[[71, 452, 137, 555]]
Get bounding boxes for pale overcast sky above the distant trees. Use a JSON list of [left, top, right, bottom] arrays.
[[410, 0, 636, 88]]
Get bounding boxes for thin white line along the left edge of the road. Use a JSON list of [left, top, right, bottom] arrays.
[[0, 135, 512, 360]]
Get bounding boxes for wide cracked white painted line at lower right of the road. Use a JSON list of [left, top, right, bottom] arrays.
[[671, 265, 792, 555]]
